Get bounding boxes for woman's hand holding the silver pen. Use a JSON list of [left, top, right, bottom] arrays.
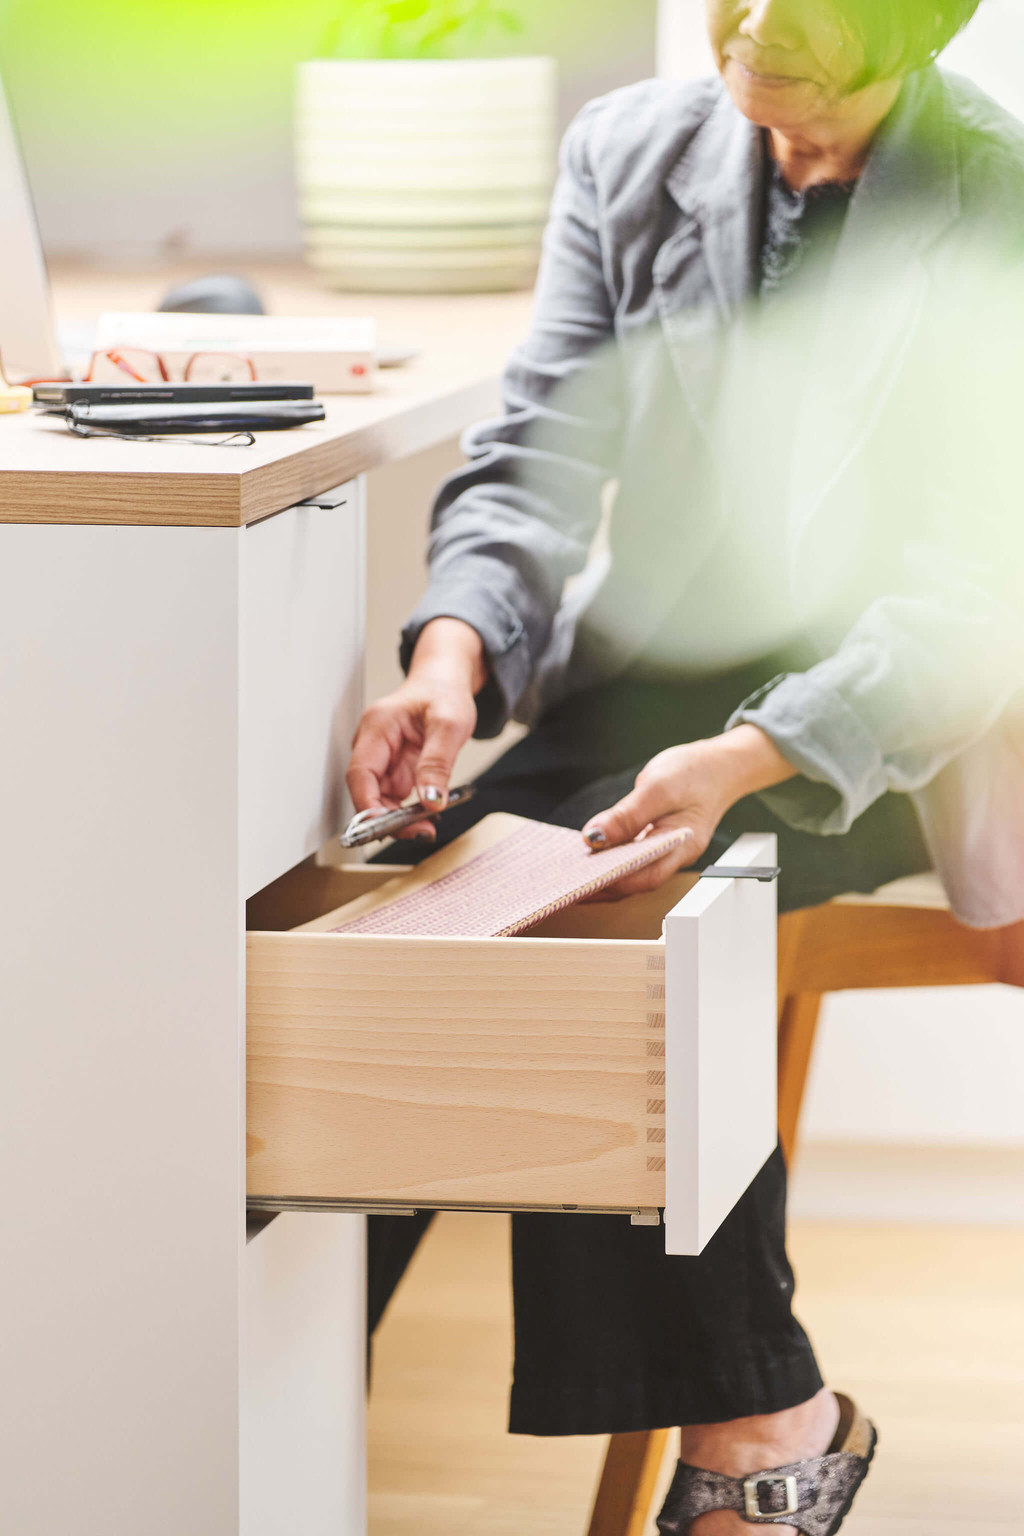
[[347, 619, 487, 837]]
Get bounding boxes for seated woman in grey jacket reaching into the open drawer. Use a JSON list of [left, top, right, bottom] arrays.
[[348, 0, 1024, 1536]]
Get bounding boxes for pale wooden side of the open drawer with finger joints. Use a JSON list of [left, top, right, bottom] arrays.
[[247, 934, 665, 1209]]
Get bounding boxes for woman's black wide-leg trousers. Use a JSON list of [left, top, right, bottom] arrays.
[[368, 660, 929, 1435]]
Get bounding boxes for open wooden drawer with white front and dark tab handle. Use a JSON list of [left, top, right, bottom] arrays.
[[247, 834, 775, 1253]]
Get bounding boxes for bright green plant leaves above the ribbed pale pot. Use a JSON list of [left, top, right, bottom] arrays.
[[318, 0, 522, 58]]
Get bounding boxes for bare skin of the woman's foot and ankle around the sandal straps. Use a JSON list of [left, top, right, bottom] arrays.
[[680, 1387, 840, 1536]]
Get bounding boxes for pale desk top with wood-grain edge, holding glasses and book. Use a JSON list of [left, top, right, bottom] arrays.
[[0, 266, 533, 528]]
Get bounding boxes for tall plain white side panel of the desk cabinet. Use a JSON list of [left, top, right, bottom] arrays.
[[0, 525, 243, 1536]]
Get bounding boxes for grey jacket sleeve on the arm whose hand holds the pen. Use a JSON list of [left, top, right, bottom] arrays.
[[401, 101, 622, 736]]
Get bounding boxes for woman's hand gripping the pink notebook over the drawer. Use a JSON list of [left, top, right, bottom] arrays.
[[583, 725, 797, 902]]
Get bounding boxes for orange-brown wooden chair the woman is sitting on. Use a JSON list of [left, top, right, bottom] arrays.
[[588, 876, 1024, 1536]]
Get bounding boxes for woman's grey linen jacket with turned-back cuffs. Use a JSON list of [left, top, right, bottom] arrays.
[[402, 68, 1024, 926]]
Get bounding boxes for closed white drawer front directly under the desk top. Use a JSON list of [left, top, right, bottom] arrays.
[[239, 481, 364, 895]]
